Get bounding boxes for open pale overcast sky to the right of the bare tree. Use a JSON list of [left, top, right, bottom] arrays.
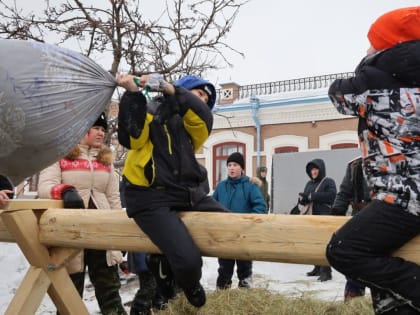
[[209, 0, 419, 85]]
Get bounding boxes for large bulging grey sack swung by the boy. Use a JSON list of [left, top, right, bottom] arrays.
[[0, 39, 116, 185]]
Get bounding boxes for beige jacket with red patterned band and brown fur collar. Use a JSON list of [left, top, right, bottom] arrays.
[[38, 144, 121, 273]]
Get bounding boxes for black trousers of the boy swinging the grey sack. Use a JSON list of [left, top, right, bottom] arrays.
[[130, 196, 224, 289]]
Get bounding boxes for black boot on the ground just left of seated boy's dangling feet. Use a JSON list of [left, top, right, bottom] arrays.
[[130, 271, 156, 315]]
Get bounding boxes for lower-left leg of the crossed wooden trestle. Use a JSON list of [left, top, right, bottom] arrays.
[[4, 266, 51, 315]]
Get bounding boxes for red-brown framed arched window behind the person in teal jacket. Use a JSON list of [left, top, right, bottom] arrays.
[[213, 142, 246, 189]]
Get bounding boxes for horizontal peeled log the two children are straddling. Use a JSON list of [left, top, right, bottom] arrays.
[[39, 209, 420, 265]]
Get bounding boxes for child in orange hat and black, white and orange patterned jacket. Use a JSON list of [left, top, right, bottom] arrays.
[[327, 7, 420, 314]]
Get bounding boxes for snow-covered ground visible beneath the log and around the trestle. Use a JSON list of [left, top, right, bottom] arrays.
[[0, 243, 360, 315]]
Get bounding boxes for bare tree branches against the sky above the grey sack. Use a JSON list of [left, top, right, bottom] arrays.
[[0, 0, 247, 80]]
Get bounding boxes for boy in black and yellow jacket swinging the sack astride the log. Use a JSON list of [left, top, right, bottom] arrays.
[[117, 74, 225, 314]]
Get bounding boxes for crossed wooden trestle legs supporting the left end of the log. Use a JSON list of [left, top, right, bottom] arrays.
[[1, 202, 88, 315]]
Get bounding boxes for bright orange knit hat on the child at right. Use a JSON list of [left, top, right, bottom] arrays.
[[368, 6, 420, 50]]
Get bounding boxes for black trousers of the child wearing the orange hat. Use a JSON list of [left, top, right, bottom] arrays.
[[326, 200, 420, 314]]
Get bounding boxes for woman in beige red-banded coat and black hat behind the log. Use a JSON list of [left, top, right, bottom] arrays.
[[38, 113, 126, 315]]
